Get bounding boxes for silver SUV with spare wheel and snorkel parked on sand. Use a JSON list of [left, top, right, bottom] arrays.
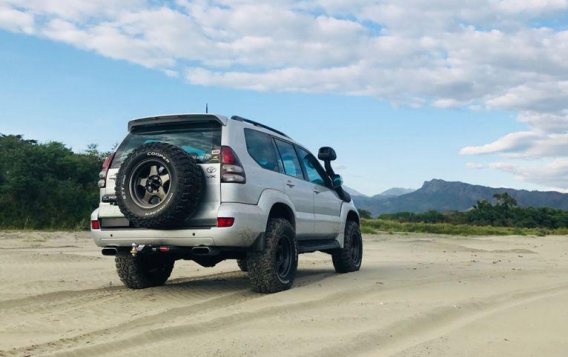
[[91, 114, 363, 293]]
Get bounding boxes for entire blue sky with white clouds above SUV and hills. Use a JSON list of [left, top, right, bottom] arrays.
[[0, 0, 568, 194]]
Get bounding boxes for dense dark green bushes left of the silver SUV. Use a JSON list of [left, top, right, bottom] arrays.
[[0, 135, 105, 229]]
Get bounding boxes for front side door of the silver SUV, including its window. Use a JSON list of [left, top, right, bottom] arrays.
[[297, 147, 342, 238]]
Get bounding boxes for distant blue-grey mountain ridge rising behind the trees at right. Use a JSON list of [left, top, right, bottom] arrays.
[[353, 179, 568, 216]]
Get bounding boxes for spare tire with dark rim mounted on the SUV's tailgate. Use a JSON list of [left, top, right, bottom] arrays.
[[115, 143, 205, 229]]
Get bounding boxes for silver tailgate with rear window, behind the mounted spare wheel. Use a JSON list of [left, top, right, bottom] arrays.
[[99, 121, 222, 226]]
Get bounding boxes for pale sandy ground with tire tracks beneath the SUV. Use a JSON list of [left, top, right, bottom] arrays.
[[0, 232, 568, 356]]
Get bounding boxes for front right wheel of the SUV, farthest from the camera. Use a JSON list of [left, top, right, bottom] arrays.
[[331, 221, 363, 274]]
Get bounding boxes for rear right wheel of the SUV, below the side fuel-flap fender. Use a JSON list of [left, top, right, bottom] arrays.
[[247, 218, 298, 294]]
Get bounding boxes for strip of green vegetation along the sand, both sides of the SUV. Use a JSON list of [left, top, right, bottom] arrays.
[[0, 135, 568, 235]]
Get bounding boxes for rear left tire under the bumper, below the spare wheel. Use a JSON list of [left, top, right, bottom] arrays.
[[115, 254, 175, 289]]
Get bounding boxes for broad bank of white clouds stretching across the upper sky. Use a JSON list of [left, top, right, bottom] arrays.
[[0, 0, 568, 188]]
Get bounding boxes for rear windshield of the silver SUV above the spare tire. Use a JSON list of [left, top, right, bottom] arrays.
[[111, 123, 221, 168]]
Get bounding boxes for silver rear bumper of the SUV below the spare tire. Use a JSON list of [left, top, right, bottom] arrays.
[[91, 203, 268, 248]]
